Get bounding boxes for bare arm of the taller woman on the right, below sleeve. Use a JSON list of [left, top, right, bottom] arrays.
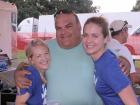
[[119, 85, 139, 105]]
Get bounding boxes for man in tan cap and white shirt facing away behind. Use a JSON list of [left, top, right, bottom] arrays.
[[107, 20, 140, 83]]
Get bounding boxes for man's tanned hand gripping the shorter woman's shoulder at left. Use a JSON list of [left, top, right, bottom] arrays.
[[14, 62, 31, 88]]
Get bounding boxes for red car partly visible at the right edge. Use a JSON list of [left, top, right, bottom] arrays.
[[127, 26, 140, 55]]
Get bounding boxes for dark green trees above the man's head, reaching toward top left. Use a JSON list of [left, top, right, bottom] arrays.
[[4, 0, 98, 23]]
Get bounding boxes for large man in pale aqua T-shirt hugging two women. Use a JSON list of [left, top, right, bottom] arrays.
[[15, 9, 129, 105]]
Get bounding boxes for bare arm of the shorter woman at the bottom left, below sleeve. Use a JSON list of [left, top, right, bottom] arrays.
[[15, 92, 30, 105]]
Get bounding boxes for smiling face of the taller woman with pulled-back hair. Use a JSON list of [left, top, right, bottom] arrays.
[[82, 23, 108, 60]]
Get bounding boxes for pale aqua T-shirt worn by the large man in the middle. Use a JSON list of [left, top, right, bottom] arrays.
[[46, 40, 102, 105]]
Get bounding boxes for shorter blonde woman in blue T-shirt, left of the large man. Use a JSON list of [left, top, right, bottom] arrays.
[[16, 39, 50, 105]]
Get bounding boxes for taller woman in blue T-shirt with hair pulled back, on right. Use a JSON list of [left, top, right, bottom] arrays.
[[83, 17, 138, 105]]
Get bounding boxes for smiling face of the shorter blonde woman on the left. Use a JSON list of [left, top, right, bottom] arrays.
[[29, 46, 50, 72]]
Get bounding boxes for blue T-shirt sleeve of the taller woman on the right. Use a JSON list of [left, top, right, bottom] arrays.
[[101, 59, 130, 93]]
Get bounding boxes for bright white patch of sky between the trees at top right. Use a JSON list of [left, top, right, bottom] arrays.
[[92, 0, 136, 12]]
